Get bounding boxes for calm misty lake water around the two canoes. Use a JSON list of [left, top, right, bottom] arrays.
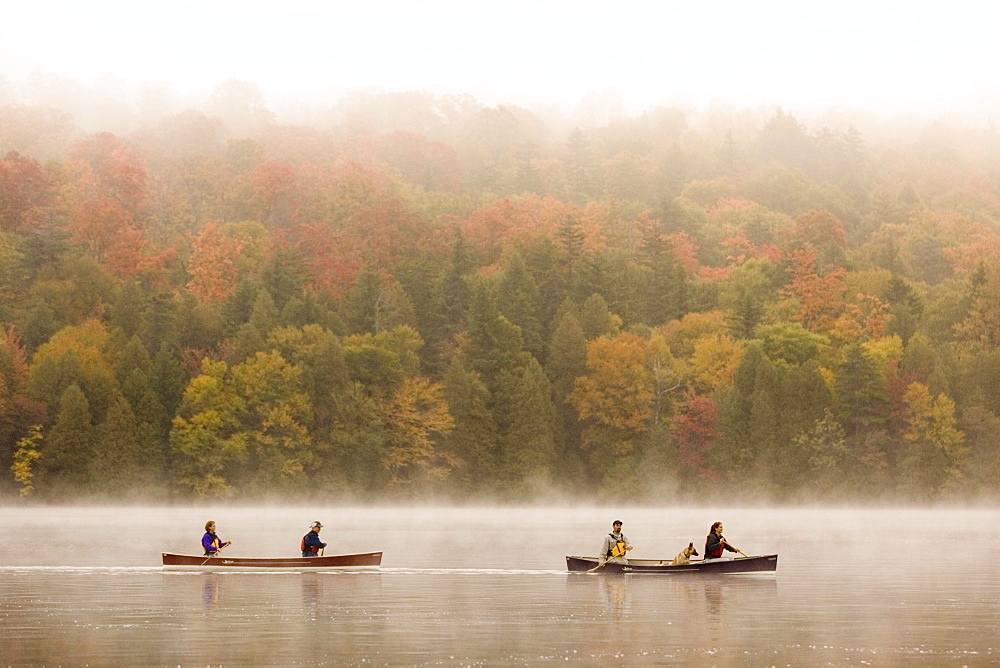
[[0, 506, 1000, 666]]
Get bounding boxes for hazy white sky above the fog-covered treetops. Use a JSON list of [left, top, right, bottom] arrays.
[[0, 0, 1000, 113]]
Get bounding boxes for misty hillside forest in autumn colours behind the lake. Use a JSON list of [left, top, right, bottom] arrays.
[[0, 82, 1000, 502]]
